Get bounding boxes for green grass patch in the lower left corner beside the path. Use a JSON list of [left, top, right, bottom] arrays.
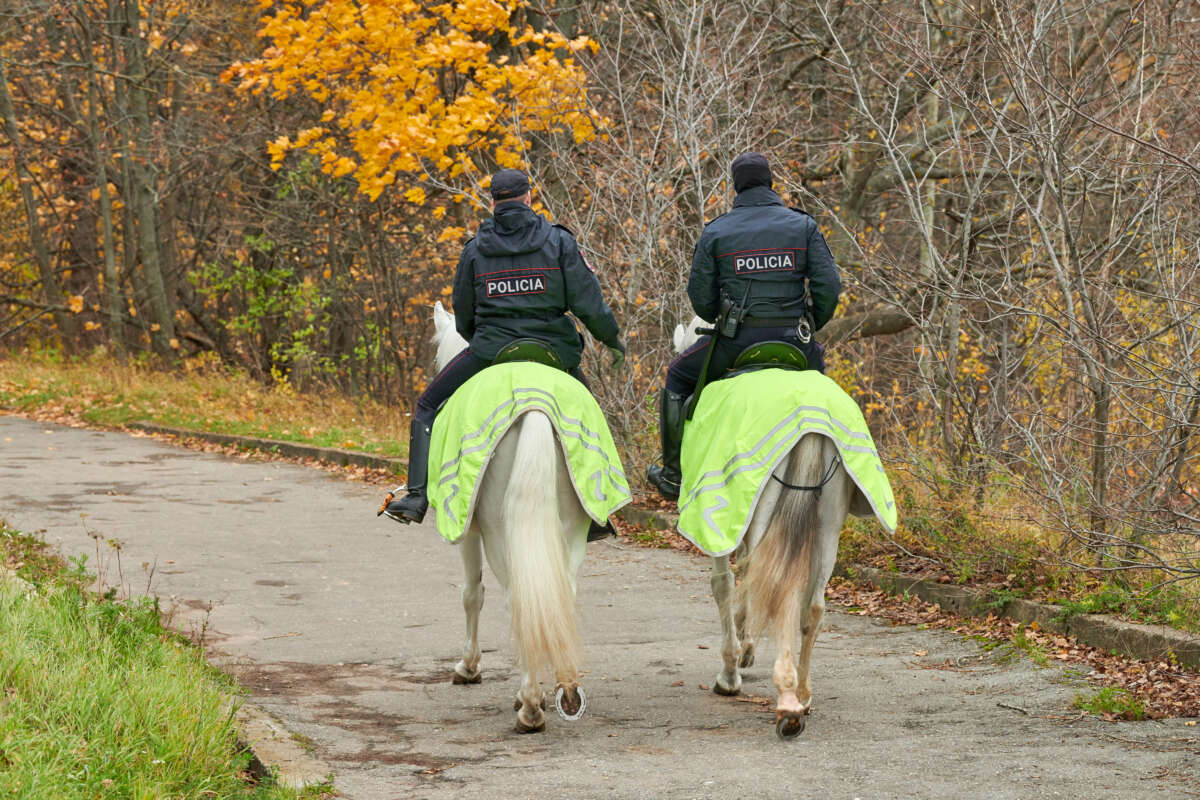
[[0, 523, 323, 800]]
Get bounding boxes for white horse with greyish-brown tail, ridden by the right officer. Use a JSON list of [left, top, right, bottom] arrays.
[[674, 317, 872, 739]]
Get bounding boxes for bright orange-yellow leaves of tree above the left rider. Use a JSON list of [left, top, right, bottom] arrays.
[[223, 0, 602, 204]]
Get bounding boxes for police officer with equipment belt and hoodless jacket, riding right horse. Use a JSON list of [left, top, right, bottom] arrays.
[[646, 152, 841, 500]]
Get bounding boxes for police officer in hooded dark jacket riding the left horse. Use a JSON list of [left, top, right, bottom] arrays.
[[384, 169, 625, 524]]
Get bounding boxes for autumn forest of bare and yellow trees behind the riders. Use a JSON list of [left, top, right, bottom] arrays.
[[0, 0, 1200, 622]]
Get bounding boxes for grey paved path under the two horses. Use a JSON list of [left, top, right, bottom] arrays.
[[0, 416, 1200, 800]]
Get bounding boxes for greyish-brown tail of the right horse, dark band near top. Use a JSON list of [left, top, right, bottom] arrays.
[[740, 434, 824, 640]]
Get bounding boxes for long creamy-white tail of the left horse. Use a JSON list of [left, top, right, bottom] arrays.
[[504, 411, 582, 678]]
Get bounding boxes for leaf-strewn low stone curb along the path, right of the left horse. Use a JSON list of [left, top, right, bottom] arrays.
[[617, 506, 1200, 669]]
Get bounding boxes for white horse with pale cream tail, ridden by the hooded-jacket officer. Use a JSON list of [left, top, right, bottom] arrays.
[[433, 302, 590, 733]]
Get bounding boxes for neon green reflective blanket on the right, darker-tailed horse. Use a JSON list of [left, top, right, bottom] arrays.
[[678, 369, 896, 555]]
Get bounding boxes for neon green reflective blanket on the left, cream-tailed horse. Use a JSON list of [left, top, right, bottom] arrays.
[[427, 361, 631, 542]]
